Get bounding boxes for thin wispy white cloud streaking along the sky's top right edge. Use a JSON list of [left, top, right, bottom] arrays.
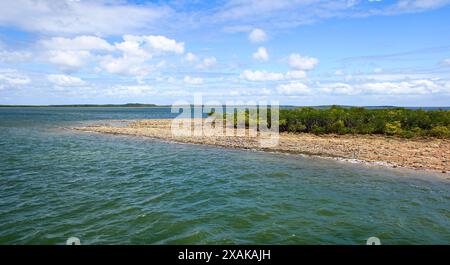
[[215, 0, 450, 29]]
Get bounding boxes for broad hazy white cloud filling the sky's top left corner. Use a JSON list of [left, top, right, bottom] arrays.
[[0, 0, 172, 35]]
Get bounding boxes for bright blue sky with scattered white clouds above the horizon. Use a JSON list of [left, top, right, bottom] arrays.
[[0, 0, 450, 106]]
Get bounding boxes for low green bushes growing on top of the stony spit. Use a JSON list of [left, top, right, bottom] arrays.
[[211, 106, 450, 138]]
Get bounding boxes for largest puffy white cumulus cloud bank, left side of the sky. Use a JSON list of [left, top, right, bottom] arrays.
[[39, 35, 184, 76]]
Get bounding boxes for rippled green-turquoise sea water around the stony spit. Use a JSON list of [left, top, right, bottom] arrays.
[[0, 108, 450, 244]]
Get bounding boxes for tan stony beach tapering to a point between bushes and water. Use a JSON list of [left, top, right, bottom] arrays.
[[74, 119, 450, 173]]
